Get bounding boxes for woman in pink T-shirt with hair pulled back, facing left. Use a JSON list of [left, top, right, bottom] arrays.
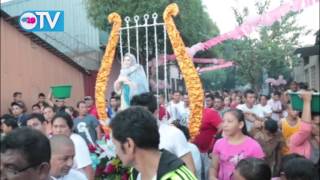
[[209, 109, 264, 180]]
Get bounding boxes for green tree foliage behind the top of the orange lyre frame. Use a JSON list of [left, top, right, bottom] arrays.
[[86, 0, 219, 57]]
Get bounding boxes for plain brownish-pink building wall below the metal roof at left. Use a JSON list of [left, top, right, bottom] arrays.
[[0, 11, 90, 114]]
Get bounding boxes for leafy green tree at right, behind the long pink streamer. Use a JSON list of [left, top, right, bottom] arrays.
[[229, 0, 309, 90]]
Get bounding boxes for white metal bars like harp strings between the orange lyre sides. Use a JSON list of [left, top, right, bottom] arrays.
[[119, 13, 171, 115]]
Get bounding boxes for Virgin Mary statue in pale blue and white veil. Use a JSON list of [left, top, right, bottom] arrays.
[[114, 53, 149, 110]]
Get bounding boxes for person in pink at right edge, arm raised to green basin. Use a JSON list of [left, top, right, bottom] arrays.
[[289, 91, 320, 162]]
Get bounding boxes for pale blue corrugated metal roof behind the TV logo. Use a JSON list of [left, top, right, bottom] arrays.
[[1, 0, 102, 70]]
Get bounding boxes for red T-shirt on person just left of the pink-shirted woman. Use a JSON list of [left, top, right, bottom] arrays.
[[193, 108, 222, 153]]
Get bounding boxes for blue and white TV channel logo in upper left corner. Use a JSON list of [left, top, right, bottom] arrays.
[[19, 10, 64, 32]]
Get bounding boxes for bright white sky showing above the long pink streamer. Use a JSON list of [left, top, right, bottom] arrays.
[[1, 0, 320, 45]]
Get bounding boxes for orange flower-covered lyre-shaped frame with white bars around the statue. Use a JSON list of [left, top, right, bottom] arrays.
[[95, 3, 204, 138]]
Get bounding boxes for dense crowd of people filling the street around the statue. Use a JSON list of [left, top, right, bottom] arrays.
[[0, 82, 320, 180]]
